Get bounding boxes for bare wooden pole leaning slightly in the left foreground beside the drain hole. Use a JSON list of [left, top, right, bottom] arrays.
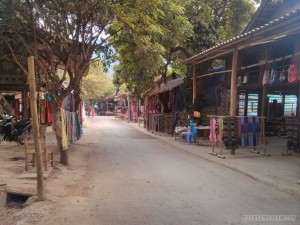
[[27, 56, 44, 200]]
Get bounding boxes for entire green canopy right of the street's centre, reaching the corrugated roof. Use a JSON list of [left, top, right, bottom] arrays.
[[112, 0, 255, 93]]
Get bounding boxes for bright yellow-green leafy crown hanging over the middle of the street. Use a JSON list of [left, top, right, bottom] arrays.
[[111, 0, 192, 95]]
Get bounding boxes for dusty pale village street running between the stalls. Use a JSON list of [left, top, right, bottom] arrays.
[[8, 117, 300, 225]]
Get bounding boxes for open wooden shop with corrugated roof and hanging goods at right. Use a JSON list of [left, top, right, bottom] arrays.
[[186, 1, 300, 156]]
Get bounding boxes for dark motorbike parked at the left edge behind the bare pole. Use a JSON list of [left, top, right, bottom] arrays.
[[0, 115, 32, 145]]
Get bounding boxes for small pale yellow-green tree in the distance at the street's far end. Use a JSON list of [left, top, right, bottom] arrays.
[[82, 61, 115, 104]]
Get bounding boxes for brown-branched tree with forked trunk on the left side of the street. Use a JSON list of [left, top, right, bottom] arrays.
[[0, 0, 118, 164]]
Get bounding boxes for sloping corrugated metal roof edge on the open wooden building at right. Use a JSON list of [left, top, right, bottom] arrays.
[[185, 9, 300, 63]]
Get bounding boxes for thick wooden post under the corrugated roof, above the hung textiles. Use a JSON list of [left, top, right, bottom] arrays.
[[230, 48, 238, 116]]
